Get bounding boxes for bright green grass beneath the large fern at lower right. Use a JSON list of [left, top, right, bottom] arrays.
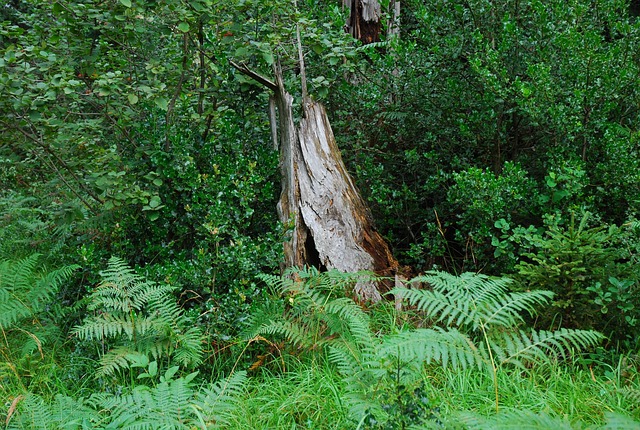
[[425, 366, 640, 426]]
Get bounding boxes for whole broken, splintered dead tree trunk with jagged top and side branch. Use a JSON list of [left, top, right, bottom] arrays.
[[232, 62, 398, 302]]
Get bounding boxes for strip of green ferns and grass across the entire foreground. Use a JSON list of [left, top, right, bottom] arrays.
[[0, 264, 640, 429]]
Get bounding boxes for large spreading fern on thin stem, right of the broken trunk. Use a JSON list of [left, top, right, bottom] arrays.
[[380, 271, 603, 410]]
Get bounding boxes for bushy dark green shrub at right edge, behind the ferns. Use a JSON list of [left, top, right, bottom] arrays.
[[504, 212, 640, 340]]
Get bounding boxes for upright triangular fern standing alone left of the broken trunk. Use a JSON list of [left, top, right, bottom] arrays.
[[74, 257, 203, 377]]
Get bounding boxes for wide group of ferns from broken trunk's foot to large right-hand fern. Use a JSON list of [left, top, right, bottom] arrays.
[[247, 269, 602, 425]]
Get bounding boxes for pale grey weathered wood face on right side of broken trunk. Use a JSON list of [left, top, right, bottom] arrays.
[[296, 102, 398, 301]]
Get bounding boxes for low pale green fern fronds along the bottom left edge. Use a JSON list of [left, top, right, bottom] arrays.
[[7, 367, 246, 430]]
